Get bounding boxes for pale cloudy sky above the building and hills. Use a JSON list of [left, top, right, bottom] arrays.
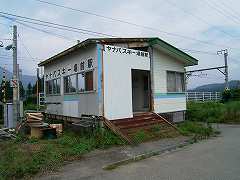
[[0, 0, 240, 87]]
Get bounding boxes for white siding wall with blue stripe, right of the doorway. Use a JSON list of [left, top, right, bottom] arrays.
[[153, 49, 186, 113]]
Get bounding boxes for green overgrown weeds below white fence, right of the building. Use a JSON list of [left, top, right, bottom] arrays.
[[186, 101, 240, 123]]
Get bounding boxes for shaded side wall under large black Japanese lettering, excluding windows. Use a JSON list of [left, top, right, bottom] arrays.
[[44, 45, 99, 117]]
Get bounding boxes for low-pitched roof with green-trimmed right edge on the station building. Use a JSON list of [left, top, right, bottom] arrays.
[[38, 37, 198, 66]]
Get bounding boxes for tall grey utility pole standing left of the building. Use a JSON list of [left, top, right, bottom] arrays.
[[12, 25, 18, 127]]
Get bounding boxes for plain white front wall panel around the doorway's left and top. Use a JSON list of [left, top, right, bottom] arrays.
[[103, 45, 150, 120]]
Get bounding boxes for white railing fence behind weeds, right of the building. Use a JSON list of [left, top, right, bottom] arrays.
[[186, 92, 222, 102]]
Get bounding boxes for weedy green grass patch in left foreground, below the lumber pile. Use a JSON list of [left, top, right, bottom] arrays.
[[0, 130, 124, 179]]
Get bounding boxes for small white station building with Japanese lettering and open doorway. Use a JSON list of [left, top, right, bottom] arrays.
[[39, 38, 198, 122]]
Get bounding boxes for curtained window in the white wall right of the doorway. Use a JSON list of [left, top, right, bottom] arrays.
[[167, 71, 185, 92]]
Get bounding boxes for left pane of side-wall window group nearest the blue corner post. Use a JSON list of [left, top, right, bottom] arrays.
[[64, 74, 77, 93]]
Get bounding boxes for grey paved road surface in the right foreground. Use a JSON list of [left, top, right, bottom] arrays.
[[36, 125, 240, 180]]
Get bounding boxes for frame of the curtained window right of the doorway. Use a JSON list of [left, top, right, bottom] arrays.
[[166, 71, 186, 93]]
